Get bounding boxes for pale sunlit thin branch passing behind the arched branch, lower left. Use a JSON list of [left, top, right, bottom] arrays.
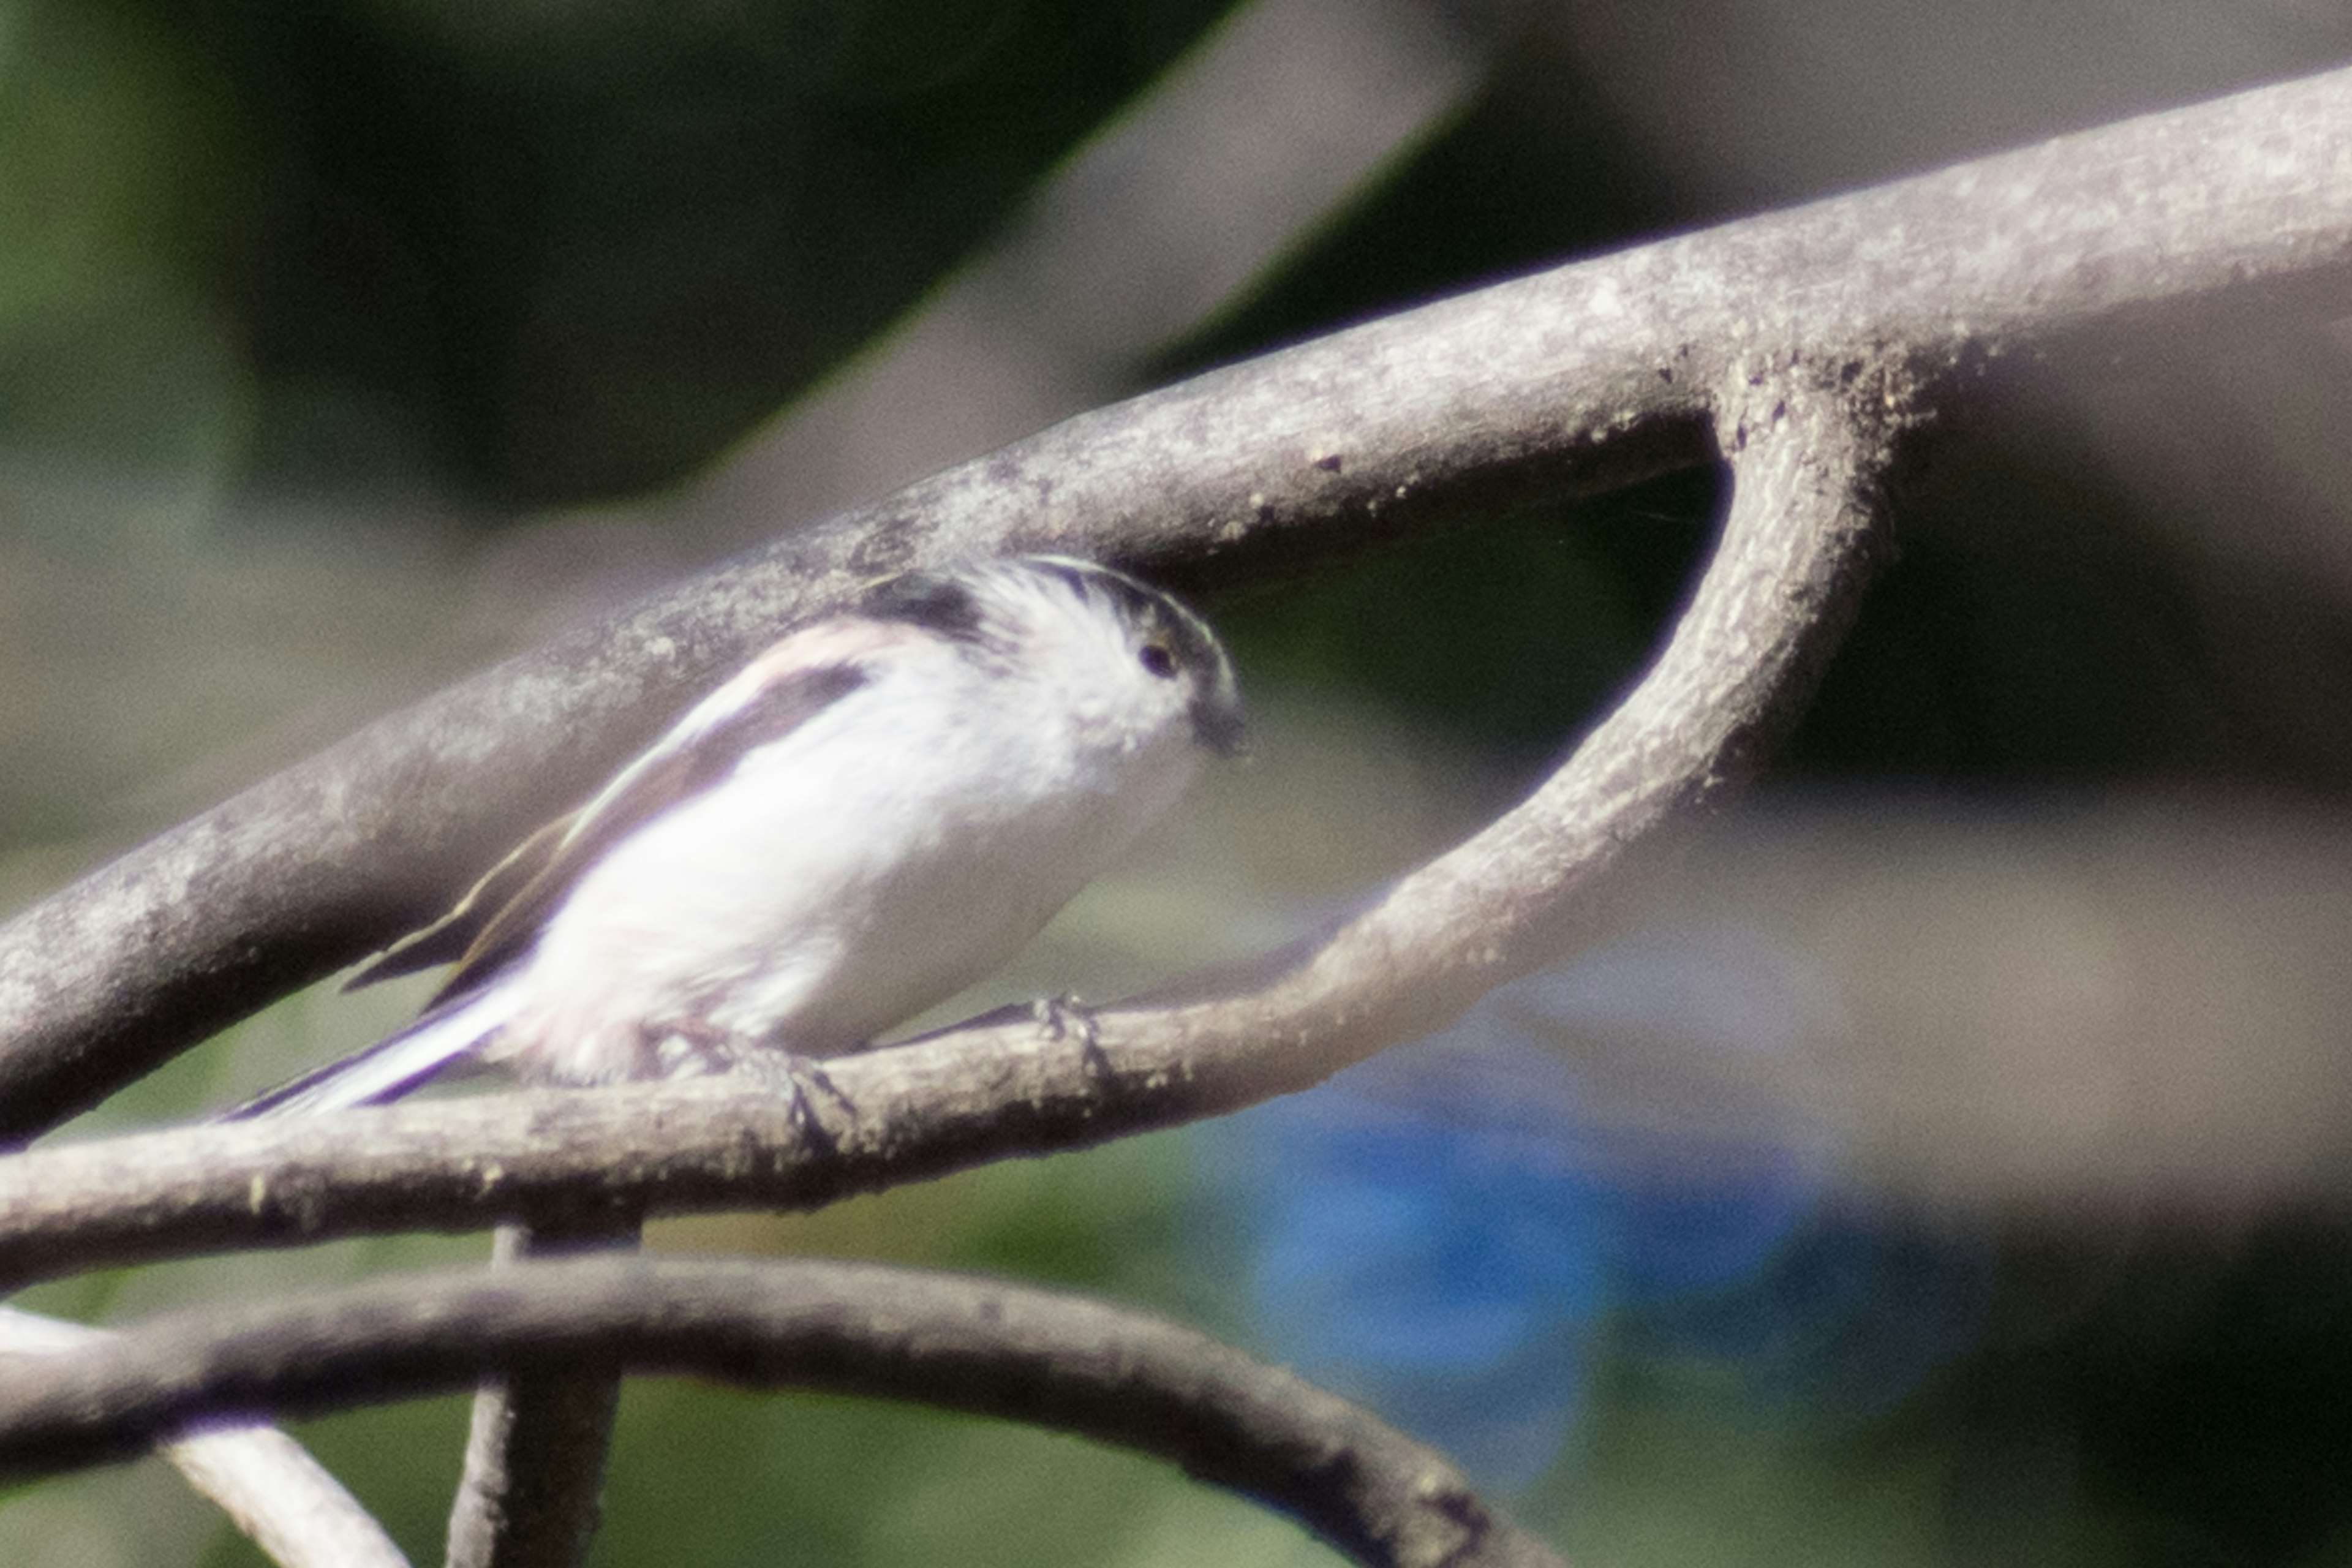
[[0, 1307, 409, 1568]]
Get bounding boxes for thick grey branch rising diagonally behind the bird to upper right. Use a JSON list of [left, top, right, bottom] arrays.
[[0, 70, 2352, 1138]]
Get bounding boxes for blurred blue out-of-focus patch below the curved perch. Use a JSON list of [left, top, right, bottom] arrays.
[[1202, 926, 1990, 1488]]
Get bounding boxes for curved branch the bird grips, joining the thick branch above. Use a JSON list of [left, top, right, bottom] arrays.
[[0, 369, 1905, 1281]]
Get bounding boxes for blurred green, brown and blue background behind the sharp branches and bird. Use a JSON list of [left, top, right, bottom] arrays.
[[13, 0, 2352, 1568]]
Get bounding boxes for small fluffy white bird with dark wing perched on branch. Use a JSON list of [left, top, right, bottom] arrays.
[[230, 555, 1242, 1117]]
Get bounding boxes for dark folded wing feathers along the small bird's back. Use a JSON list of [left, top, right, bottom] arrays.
[[353, 665, 865, 1006]]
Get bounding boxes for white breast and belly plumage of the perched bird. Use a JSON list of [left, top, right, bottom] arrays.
[[501, 649, 1197, 1082]]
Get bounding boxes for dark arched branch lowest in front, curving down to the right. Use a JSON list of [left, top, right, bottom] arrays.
[[0, 1257, 1559, 1568]]
